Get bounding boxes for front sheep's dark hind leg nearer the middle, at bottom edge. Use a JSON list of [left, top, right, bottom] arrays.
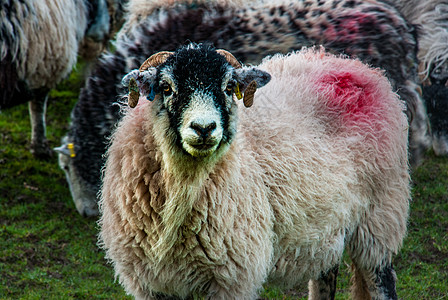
[[308, 266, 339, 300]]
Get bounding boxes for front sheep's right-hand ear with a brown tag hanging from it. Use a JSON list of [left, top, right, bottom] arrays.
[[235, 67, 271, 107]]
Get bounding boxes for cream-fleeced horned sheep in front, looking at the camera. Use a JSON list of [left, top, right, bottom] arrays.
[[99, 44, 410, 299]]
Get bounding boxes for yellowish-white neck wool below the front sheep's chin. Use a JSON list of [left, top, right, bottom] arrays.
[[151, 106, 236, 259]]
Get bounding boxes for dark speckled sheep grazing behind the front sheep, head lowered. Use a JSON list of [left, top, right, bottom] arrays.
[[57, 0, 431, 216]]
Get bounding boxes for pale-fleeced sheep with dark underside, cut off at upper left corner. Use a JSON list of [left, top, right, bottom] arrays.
[[0, 0, 120, 157]]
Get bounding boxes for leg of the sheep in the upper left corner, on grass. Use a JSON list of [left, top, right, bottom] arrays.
[[29, 89, 52, 158]]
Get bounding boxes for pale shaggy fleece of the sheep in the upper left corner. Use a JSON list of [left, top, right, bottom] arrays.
[[0, 0, 87, 89]]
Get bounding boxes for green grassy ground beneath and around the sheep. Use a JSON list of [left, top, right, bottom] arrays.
[[0, 67, 448, 299]]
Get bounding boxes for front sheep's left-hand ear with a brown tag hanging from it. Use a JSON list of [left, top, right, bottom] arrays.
[[121, 68, 157, 108]]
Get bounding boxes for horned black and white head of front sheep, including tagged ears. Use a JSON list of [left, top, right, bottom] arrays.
[[123, 44, 270, 157]]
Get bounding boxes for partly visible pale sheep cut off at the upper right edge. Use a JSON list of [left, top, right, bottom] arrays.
[[386, 0, 448, 155]]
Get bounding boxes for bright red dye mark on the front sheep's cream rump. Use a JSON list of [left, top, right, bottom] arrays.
[[319, 72, 381, 121]]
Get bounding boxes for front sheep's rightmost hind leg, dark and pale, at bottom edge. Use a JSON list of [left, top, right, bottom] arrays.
[[351, 264, 398, 300]]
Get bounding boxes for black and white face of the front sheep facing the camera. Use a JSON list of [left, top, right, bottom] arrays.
[[159, 66, 231, 157]]
